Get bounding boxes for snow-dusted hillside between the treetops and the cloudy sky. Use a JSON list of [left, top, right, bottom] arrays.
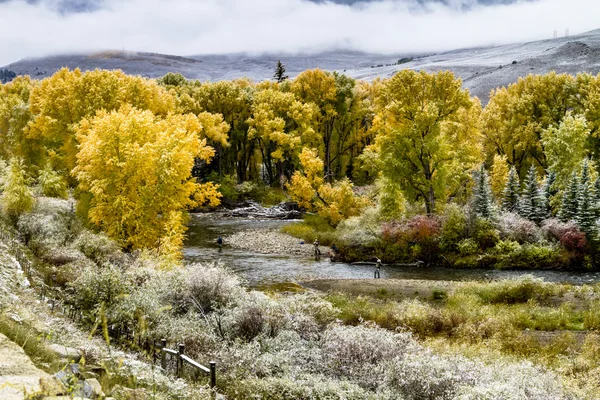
[[3, 30, 600, 103]]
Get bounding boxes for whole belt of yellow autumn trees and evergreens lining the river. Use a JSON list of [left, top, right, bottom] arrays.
[[0, 69, 600, 265]]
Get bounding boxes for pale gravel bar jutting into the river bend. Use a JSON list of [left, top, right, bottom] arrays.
[[224, 228, 331, 257]]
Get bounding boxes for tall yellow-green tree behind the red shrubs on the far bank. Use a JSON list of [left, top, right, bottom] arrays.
[[373, 70, 482, 214]]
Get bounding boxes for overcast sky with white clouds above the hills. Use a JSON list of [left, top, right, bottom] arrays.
[[0, 0, 600, 65]]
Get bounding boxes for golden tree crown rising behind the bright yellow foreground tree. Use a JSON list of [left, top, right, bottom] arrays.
[[28, 68, 175, 178]]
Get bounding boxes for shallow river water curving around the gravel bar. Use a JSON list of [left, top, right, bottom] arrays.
[[183, 214, 600, 287]]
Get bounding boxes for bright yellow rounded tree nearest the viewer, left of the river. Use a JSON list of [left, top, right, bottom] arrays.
[[73, 106, 220, 255]]
